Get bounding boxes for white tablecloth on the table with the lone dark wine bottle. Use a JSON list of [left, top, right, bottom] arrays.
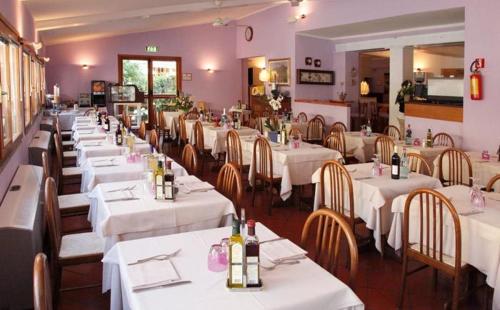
[[312, 163, 442, 251]]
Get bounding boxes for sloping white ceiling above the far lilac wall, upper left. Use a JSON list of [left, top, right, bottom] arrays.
[[22, 0, 287, 45]]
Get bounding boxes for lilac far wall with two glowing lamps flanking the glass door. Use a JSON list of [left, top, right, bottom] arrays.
[[47, 25, 241, 109]]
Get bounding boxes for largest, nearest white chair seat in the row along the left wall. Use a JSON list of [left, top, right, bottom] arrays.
[[59, 232, 104, 260]]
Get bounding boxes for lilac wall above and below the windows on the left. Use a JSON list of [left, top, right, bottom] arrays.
[[0, 0, 40, 200]]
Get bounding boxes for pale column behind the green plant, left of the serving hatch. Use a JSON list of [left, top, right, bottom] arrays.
[[389, 46, 413, 130]]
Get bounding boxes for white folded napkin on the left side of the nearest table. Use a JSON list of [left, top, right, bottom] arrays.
[[127, 260, 181, 290]]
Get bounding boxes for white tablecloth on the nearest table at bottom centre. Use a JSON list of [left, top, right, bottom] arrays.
[[103, 223, 364, 310]]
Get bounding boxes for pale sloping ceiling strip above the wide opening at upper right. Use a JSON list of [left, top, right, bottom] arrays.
[[296, 8, 465, 42]]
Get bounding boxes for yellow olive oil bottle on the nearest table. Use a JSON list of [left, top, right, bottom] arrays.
[[228, 219, 244, 288]]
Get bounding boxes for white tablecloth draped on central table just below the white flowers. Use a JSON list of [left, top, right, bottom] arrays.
[[241, 136, 342, 200]]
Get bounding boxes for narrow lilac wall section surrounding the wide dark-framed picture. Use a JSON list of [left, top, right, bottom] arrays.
[[295, 35, 334, 100]]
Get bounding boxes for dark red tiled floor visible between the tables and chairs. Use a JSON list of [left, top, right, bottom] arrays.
[[58, 143, 485, 310]]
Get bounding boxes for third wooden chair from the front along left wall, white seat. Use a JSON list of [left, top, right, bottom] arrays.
[[42, 152, 90, 217]]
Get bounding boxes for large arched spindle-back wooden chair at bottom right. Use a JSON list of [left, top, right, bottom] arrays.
[[399, 189, 468, 310]]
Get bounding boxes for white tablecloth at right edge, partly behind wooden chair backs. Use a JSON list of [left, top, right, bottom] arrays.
[[434, 152, 500, 192]]
